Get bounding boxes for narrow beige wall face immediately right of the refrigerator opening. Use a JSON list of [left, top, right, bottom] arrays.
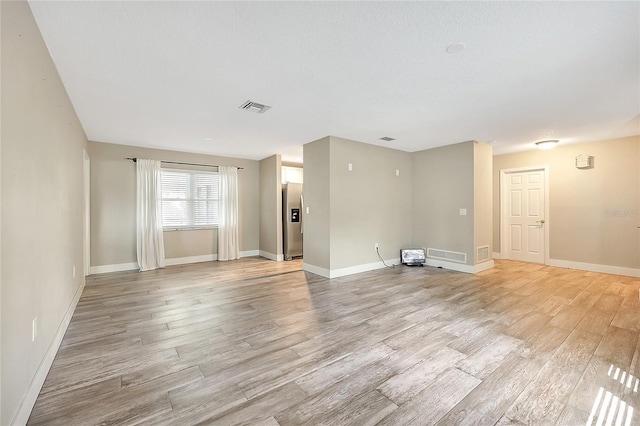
[[302, 136, 330, 269]]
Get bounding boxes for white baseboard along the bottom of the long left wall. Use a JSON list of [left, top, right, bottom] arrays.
[[11, 278, 85, 425]]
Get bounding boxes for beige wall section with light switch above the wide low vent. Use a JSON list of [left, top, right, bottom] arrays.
[[412, 141, 478, 265]]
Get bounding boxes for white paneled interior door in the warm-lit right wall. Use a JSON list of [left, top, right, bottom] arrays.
[[501, 169, 548, 264]]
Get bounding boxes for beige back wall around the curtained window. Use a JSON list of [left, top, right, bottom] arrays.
[[88, 142, 260, 266]]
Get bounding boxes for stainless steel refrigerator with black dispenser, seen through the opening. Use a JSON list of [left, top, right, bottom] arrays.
[[282, 183, 304, 260]]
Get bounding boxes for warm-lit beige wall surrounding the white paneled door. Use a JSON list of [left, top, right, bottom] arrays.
[[493, 136, 640, 268]]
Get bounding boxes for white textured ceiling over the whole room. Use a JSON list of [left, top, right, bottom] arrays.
[[30, 1, 640, 161]]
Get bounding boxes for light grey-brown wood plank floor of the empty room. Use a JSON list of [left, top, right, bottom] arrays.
[[29, 258, 640, 426]]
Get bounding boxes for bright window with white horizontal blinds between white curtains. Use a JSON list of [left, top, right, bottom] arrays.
[[161, 169, 219, 229]]
